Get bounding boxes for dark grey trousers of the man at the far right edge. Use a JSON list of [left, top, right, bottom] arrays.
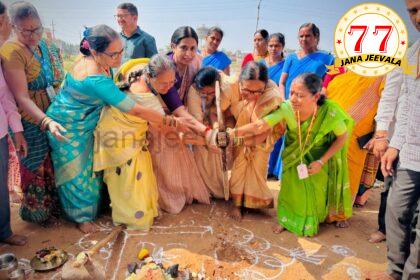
[[385, 167, 420, 279]]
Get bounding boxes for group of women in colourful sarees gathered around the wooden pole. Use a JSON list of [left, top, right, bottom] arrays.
[[0, 2, 384, 242]]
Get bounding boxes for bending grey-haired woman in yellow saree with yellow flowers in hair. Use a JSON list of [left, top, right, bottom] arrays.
[[94, 55, 185, 230]]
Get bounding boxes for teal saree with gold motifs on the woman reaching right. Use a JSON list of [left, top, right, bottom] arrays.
[[47, 74, 104, 223]]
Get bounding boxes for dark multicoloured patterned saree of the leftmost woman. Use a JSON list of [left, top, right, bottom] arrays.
[[1, 40, 63, 224]]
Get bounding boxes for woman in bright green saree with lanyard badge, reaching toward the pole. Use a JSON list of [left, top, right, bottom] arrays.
[[219, 73, 353, 236]]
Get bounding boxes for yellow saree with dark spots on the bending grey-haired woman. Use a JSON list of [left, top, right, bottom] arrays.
[[93, 93, 159, 230]]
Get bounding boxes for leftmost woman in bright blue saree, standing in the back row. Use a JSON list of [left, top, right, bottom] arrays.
[[201, 26, 232, 75]]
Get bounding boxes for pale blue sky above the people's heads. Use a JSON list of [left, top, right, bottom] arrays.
[[4, 0, 420, 52]]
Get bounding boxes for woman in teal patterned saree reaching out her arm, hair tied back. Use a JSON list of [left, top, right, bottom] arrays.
[[47, 25, 190, 233]]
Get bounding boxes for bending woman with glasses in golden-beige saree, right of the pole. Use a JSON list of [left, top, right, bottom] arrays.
[[226, 61, 281, 220]]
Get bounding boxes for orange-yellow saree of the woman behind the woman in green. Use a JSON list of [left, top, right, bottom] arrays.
[[327, 71, 384, 201]]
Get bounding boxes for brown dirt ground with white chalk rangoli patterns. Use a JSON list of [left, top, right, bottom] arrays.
[[0, 182, 386, 280]]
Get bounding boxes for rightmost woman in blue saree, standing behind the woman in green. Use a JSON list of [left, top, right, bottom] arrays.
[[279, 23, 334, 99]]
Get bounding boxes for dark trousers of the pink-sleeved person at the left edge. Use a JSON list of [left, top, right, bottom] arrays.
[[0, 136, 12, 241]]
